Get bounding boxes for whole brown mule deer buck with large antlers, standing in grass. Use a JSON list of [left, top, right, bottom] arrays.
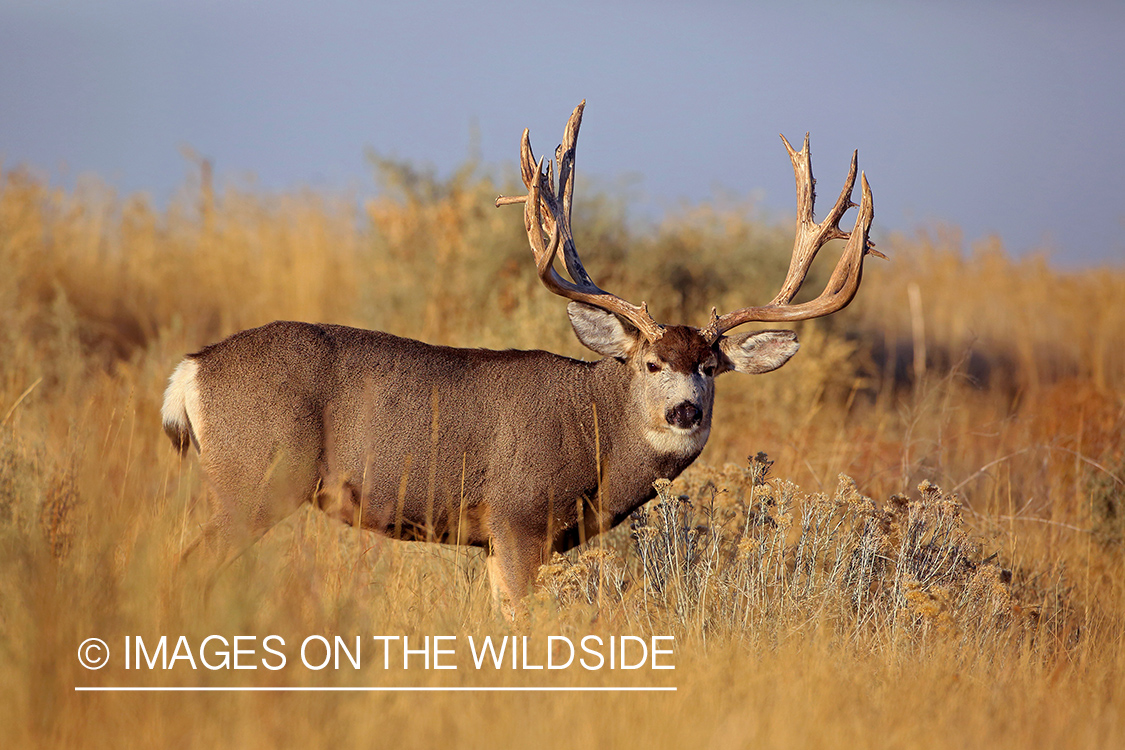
[[163, 102, 882, 607]]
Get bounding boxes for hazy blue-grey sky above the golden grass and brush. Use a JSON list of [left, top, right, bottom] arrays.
[[0, 0, 1125, 266]]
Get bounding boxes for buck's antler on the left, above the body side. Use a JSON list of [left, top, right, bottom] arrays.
[[496, 100, 664, 342]]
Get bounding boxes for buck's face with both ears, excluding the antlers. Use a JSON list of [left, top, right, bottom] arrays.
[[567, 302, 798, 453]]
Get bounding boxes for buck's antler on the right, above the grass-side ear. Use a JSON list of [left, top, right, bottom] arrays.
[[703, 133, 887, 343]]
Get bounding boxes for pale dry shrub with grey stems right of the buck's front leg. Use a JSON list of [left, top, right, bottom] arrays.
[[627, 454, 1062, 649]]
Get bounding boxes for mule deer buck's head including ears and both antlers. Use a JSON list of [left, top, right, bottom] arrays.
[[496, 101, 884, 453]]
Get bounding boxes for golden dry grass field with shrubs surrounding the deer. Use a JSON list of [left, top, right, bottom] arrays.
[[0, 157, 1125, 748]]
